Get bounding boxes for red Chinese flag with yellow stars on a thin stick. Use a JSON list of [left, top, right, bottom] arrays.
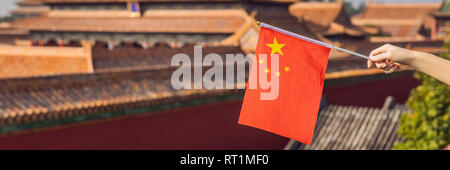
[[239, 27, 330, 144]]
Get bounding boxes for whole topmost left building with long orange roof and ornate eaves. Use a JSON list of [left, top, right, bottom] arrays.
[[11, 0, 315, 48]]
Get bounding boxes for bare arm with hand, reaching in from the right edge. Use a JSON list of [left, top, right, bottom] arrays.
[[367, 44, 450, 85]]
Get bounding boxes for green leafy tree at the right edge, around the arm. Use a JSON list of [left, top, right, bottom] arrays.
[[394, 38, 450, 150]]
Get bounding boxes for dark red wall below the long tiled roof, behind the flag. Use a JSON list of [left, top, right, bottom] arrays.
[[0, 73, 419, 149]]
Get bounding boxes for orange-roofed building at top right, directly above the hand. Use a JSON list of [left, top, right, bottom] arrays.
[[352, 1, 440, 42]]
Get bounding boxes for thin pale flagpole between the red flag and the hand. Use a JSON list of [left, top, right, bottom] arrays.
[[256, 21, 369, 59]]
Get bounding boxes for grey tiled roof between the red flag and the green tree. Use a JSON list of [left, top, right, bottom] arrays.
[[285, 97, 410, 150]]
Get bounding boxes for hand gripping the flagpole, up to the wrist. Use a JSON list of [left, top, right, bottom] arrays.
[[367, 44, 413, 73]]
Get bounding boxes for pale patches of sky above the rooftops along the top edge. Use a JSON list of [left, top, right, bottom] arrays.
[[0, 0, 442, 16]]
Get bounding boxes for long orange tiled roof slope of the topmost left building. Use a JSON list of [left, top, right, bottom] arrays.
[[11, 10, 247, 33]]
